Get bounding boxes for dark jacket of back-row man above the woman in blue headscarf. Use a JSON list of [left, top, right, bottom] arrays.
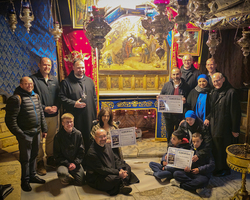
[[181, 65, 201, 90]]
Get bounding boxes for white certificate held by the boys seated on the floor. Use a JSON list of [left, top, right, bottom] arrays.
[[167, 147, 194, 169]]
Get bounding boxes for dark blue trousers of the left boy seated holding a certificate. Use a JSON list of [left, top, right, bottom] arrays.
[[149, 162, 178, 180]]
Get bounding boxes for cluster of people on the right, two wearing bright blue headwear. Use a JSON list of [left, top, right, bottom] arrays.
[[145, 55, 241, 193]]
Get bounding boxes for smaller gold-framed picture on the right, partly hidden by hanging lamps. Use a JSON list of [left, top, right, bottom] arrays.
[[178, 29, 202, 56]]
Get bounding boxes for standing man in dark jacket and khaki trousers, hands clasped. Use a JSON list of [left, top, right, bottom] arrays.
[[30, 57, 59, 176]]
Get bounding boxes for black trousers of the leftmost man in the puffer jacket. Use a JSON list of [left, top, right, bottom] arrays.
[[16, 133, 40, 181]]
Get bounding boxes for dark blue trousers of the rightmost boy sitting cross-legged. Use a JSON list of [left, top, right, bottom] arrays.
[[174, 171, 209, 191]]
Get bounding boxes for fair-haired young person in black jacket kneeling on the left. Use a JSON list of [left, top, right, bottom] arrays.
[[54, 113, 85, 185]]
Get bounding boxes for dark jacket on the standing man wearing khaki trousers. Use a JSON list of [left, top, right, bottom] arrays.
[[30, 70, 60, 117]]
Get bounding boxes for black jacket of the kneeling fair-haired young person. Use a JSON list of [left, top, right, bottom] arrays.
[[53, 127, 85, 167]]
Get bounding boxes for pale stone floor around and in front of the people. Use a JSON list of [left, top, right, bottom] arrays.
[[1, 139, 250, 200]]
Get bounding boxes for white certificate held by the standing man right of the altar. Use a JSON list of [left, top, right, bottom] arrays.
[[158, 95, 183, 113]]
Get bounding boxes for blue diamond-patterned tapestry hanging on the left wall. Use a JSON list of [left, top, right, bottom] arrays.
[[0, 0, 57, 94]]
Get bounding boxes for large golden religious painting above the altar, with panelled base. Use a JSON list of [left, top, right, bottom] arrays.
[[98, 13, 172, 94]]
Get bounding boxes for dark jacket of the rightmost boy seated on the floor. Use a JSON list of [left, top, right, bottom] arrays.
[[191, 143, 215, 178]]
